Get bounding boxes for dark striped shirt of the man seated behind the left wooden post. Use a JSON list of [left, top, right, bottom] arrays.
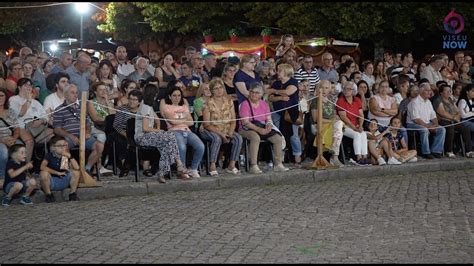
[[53, 101, 90, 137]]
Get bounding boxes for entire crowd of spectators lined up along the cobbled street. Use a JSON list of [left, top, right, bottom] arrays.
[[0, 35, 474, 206]]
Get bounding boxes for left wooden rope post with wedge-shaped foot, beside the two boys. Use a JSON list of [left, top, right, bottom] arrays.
[[79, 91, 102, 187]]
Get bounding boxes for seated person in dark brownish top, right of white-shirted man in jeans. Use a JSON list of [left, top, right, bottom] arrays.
[[433, 84, 474, 158]]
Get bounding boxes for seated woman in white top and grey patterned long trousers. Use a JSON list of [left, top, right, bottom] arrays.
[[135, 86, 190, 183]]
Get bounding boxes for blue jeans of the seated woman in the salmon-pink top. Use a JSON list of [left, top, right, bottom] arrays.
[[173, 130, 204, 170]]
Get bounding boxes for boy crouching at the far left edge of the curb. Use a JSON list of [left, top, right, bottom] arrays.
[[2, 144, 36, 207]]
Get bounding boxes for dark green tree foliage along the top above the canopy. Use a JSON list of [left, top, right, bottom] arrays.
[[96, 2, 474, 49]]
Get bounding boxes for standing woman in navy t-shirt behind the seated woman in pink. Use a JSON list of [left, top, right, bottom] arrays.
[[234, 55, 261, 104]]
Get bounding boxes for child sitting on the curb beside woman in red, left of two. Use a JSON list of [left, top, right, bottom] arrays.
[[367, 119, 401, 165]]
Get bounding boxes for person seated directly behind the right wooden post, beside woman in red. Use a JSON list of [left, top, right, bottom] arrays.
[[310, 80, 344, 166]]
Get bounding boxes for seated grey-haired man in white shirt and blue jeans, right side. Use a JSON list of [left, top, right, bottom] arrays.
[[407, 83, 446, 159]]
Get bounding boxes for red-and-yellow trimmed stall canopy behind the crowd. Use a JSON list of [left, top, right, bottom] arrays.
[[202, 36, 360, 62]]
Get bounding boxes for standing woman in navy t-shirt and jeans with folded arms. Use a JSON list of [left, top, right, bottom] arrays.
[[267, 64, 303, 167]]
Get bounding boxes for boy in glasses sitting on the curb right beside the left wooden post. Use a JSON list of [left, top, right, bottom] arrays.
[[40, 136, 80, 203]]
